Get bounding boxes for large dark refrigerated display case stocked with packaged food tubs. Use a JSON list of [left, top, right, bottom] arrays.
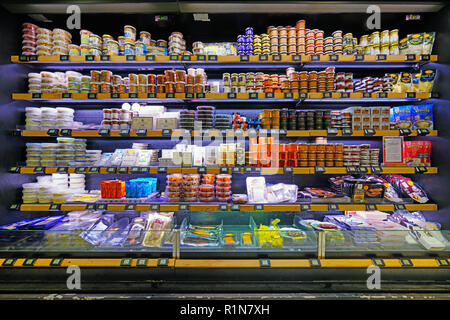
[[0, 1, 450, 293]]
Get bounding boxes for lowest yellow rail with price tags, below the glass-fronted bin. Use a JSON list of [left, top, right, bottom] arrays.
[[0, 257, 450, 269]]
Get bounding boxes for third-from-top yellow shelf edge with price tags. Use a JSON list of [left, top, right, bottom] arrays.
[[12, 129, 438, 138]]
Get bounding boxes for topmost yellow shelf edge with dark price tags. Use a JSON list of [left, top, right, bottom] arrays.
[[11, 54, 438, 68]]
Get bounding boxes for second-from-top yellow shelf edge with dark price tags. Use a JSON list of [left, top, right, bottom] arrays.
[[12, 92, 439, 103]]
